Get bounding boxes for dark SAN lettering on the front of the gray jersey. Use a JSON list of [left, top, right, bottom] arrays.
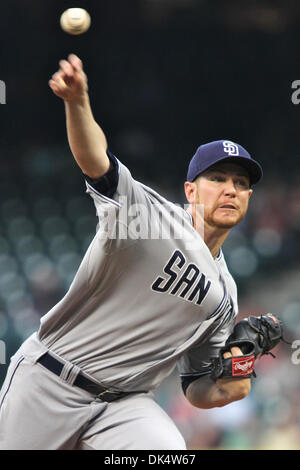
[[151, 250, 211, 305]]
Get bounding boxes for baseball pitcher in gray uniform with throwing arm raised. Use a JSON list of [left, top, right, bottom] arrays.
[[0, 54, 282, 450]]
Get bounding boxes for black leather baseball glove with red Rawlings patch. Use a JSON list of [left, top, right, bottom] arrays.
[[211, 313, 286, 380]]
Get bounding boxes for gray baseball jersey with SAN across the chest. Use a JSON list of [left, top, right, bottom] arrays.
[[38, 153, 238, 391]]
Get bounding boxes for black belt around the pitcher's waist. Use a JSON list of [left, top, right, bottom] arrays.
[[37, 353, 131, 402]]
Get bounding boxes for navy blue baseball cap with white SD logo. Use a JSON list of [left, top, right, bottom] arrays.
[[187, 140, 263, 186]]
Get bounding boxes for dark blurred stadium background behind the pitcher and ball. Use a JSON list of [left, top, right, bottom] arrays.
[[0, 0, 300, 449]]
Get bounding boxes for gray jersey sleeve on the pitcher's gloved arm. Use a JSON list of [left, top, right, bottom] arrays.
[[177, 319, 234, 393]]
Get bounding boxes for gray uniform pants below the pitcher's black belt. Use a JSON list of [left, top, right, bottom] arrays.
[[0, 338, 186, 450]]
